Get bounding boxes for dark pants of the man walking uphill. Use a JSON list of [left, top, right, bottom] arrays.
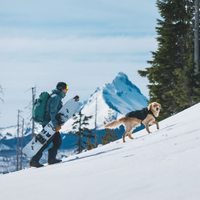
[[31, 132, 62, 162]]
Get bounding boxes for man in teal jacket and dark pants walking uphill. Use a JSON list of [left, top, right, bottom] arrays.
[[29, 82, 79, 167]]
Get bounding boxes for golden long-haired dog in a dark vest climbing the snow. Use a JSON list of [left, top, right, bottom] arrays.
[[104, 102, 161, 142]]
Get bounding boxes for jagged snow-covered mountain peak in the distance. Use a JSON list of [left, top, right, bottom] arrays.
[[62, 72, 147, 133]]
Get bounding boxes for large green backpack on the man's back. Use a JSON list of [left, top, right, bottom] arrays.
[[32, 92, 50, 124]]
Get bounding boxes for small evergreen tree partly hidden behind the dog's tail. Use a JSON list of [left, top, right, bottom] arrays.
[[101, 107, 118, 145]]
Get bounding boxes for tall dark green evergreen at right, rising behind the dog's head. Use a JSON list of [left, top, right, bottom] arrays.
[[138, 0, 199, 119]]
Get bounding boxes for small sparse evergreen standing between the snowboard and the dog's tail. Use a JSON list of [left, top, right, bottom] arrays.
[[72, 111, 94, 153]]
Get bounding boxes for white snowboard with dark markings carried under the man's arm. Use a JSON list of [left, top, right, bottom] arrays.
[[22, 99, 79, 157]]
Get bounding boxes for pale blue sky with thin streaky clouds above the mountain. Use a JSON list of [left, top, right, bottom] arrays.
[[0, 0, 160, 127]]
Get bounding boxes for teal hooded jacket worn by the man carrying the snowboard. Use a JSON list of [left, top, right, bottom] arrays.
[[42, 89, 65, 127]]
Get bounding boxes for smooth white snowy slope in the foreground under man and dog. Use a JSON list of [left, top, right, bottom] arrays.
[[0, 104, 200, 200]]
